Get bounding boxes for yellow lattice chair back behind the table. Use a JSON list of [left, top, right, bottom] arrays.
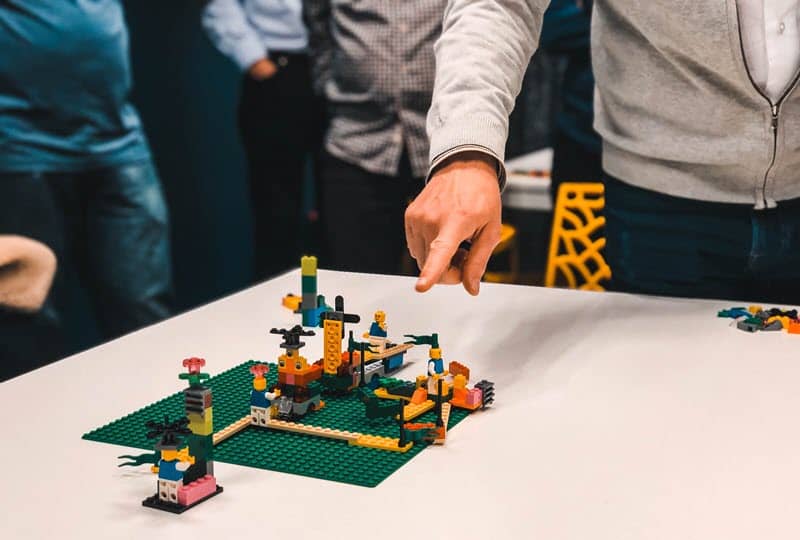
[[544, 183, 611, 291]]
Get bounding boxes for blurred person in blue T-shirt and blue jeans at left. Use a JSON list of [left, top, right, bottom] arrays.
[[0, 0, 172, 362]]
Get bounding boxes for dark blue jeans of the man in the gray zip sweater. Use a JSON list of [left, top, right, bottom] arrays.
[[605, 176, 800, 305]]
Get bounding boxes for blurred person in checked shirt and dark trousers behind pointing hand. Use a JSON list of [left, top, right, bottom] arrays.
[[304, 0, 447, 274]]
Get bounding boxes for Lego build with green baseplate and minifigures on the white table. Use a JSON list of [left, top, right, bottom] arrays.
[[84, 286, 494, 490]]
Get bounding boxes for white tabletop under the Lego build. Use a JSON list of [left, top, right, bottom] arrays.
[[0, 271, 800, 540]]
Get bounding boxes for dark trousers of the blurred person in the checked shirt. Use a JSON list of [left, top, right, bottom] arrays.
[[319, 152, 425, 274]]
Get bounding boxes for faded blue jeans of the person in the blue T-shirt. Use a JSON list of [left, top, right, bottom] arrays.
[[0, 160, 172, 346]]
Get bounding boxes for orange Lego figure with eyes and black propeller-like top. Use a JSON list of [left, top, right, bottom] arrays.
[[268, 325, 325, 420]]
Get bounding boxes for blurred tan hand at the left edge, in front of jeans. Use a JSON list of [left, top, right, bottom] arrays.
[[0, 235, 56, 311]]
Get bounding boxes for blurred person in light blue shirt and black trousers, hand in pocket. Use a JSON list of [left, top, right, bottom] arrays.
[[202, 0, 323, 279]]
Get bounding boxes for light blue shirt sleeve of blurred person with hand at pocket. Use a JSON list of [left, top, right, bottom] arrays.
[[202, 0, 267, 71]]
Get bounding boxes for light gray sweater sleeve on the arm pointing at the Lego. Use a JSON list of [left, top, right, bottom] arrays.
[[427, 0, 550, 171]]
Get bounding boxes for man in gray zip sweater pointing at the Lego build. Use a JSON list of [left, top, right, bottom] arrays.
[[406, 0, 800, 303]]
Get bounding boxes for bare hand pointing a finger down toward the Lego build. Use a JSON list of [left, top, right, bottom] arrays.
[[406, 152, 502, 295]]
